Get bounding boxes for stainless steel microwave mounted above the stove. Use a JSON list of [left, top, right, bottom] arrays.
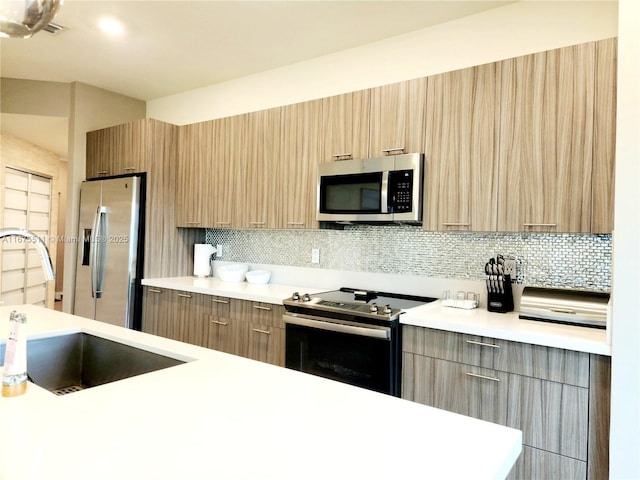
[[317, 153, 424, 223]]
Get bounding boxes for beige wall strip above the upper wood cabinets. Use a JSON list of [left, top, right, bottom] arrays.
[[147, 1, 617, 125]]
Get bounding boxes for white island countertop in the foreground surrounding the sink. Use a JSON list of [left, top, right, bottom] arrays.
[[0, 305, 522, 480]]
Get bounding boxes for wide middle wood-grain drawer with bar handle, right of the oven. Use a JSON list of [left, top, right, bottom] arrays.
[[402, 352, 589, 460]]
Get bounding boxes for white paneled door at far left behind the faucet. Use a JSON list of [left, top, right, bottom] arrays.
[[0, 167, 51, 306]]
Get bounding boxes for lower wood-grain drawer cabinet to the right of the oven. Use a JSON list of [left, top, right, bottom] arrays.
[[402, 326, 610, 480]]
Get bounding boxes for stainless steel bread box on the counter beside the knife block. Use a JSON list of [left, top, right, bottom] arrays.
[[519, 287, 609, 328]]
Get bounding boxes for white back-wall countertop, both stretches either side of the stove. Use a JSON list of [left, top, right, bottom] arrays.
[[142, 277, 611, 355]]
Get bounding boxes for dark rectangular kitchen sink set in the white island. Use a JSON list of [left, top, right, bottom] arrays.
[[0, 333, 185, 395]]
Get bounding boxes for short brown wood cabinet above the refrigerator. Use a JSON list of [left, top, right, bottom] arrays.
[[86, 119, 150, 178]]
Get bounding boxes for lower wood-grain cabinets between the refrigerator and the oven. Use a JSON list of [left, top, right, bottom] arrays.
[[142, 287, 285, 366]]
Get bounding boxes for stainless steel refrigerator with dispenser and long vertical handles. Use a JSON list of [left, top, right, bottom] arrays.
[[74, 174, 146, 330]]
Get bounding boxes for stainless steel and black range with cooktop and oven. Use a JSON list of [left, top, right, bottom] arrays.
[[283, 288, 435, 396]]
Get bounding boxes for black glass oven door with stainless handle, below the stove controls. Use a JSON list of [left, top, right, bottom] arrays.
[[284, 314, 399, 396]]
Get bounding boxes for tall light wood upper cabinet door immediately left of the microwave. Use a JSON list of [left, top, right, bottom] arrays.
[[274, 100, 322, 229]]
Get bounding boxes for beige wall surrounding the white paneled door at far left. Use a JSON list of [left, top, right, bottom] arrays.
[[0, 135, 66, 308]]
